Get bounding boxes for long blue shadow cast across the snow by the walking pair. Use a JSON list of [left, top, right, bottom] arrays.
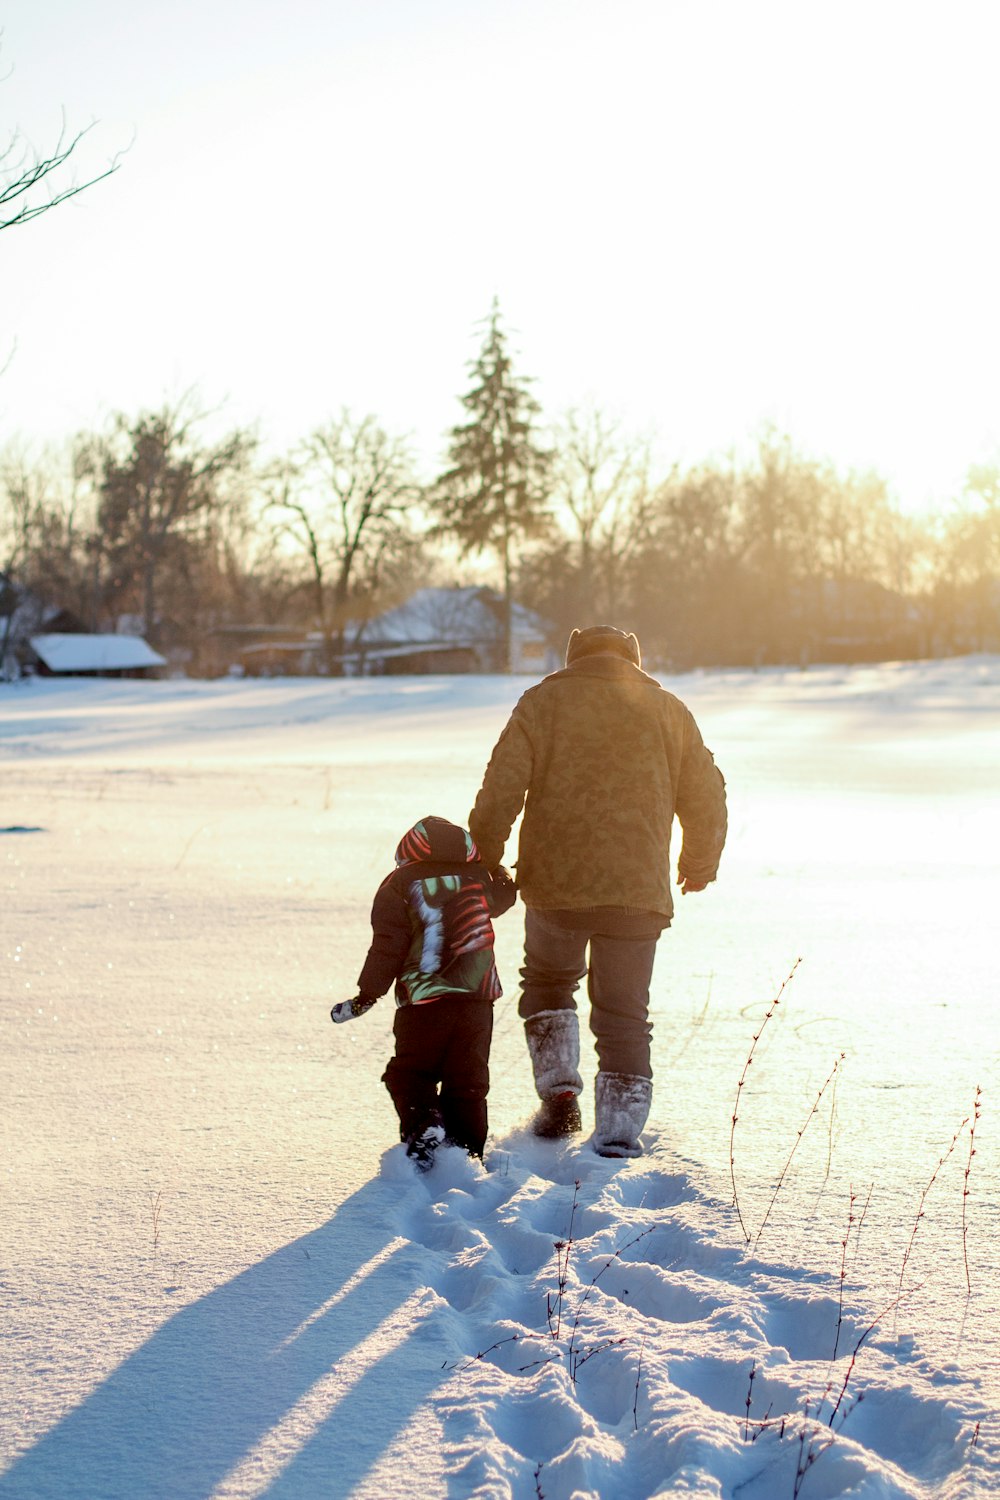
[[0, 1179, 453, 1500]]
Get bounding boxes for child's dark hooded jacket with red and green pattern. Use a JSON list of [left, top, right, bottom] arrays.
[[358, 818, 514, 1007]]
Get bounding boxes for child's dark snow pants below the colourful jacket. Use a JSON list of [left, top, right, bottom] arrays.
[[382, 995, 493, 1157]]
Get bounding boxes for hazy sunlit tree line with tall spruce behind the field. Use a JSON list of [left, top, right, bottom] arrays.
[[0, 303, 1000, 672]]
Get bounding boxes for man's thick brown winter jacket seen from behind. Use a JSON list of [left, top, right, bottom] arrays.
[[469, 654, 726, 920]]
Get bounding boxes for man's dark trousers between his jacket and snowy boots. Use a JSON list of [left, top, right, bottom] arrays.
[[517, 906, 667, 1079]]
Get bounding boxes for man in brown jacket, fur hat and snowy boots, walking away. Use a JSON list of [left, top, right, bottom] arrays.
[[469, 626, 726, 1157]]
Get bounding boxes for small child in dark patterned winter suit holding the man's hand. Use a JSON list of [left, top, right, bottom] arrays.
[[330, 818, 516, 1172]]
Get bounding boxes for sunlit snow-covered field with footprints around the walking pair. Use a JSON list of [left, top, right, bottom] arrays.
[[0, 669, 1000, 1500]]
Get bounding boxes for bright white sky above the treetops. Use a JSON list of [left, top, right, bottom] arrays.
[[0, 0, 1000, 509]]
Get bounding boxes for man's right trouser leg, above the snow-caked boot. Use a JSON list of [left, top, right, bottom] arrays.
[[588, 933, 657, 1079]]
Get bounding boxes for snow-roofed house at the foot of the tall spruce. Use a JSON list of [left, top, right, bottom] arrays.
[[352, 587, 561, 677]]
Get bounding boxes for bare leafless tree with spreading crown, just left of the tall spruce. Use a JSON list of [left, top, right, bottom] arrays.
[[271, 410, 420, 671]]
